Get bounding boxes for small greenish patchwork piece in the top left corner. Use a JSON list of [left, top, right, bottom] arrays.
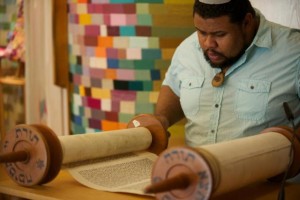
[[0, 0, 18, 46]]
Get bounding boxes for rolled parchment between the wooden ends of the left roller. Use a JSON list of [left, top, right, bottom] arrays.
[[59, 127, 152, 164]]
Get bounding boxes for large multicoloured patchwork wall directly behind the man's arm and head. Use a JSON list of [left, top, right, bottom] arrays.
[[68, 0, 194, 134]]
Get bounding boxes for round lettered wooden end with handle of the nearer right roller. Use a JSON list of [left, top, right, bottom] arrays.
[[145, 147, 218, 200]]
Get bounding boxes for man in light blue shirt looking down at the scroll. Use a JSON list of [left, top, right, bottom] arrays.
[[155, 0, 300, 146]]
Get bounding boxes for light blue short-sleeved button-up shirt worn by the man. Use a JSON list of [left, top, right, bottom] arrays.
[[163, 11, 300, 146]]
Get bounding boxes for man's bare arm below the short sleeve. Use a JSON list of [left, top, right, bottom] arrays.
[[155, 85, 184, 128]]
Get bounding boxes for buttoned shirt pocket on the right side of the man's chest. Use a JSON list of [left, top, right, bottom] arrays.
[[234, 80, 271, 121]]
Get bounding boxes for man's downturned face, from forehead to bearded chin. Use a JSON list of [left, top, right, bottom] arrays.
[[194, 14, 247, 68]]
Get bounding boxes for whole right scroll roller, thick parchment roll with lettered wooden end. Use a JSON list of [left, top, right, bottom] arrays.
[[145, 127, 300, 200]]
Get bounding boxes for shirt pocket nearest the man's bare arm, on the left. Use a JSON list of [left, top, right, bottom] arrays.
[[180, 77, 204, 116]]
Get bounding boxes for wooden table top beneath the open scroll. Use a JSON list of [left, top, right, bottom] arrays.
[[0, 129, 300, 200]]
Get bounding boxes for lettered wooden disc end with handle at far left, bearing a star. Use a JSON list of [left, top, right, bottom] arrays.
[[0, 125, 62, 186]]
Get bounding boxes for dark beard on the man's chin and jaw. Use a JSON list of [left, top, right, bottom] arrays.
[[203, 47, 247, 69]]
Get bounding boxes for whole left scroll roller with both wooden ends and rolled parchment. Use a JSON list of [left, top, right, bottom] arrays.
[[0, 114, 168, 186]]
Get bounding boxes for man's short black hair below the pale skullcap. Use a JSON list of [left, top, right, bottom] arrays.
[[193, 0, 255, 23]]
